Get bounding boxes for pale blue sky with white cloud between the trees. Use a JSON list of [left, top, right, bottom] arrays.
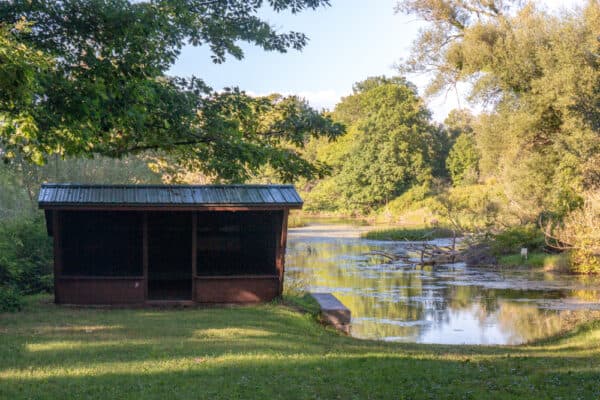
[[170, 0, 582, 122]]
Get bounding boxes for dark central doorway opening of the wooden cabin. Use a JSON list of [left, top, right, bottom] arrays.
[[148, 211, 192, 300]]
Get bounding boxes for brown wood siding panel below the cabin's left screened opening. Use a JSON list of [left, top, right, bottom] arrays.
[[54, 277, 144, 305]]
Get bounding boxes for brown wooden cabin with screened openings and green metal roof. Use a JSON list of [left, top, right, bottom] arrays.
[[39, 184, 302, 304]]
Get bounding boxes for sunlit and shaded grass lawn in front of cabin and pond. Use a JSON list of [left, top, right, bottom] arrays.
[[0, 297, 600, 399]]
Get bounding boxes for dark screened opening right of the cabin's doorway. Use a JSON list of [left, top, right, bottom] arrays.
[[197, 211, 283, 276]]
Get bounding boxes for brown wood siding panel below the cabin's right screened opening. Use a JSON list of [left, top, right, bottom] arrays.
[[194, 276, 279, 303]]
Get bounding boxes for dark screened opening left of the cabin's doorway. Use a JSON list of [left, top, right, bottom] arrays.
[[61, 211, 144, 277]]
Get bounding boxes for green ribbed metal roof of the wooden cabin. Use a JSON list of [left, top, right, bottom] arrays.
[[38, 183, 302, 208]]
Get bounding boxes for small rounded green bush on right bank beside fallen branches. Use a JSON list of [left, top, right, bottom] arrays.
[[492, 224, 546, 255]]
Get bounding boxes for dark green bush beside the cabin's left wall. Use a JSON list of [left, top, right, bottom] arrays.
[[0, 216, 53, 294]]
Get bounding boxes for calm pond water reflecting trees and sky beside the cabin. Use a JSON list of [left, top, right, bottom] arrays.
[[286, 223, 600, 344]]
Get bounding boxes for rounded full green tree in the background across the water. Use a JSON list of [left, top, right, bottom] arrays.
[[309, 77, 438, 213]]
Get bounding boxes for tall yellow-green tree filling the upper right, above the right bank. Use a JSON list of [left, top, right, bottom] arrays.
[[398, 0, 600, 220]]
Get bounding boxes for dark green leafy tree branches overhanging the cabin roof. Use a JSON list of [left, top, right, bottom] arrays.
[[0, 0, 343, 181]]
